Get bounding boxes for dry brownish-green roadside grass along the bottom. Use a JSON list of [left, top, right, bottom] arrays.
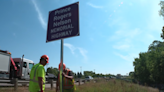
[[0, 80, 159, 92]]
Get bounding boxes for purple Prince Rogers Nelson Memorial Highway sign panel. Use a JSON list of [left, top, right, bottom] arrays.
[[46, 2, 80, 42]]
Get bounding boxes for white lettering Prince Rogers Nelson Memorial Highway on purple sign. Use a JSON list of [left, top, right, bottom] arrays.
[[51, 7, 74, 39]]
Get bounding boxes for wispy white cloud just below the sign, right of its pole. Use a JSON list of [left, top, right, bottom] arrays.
[[64, 43, 88, 60]]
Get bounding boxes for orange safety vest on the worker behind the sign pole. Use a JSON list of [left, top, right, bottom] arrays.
[[58, 70, 74, 89]]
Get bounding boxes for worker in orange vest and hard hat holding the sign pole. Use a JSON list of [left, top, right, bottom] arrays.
[[56, 63, 76, 92]]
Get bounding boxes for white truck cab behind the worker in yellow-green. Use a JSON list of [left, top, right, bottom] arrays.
[[13, 58, 34, 80]]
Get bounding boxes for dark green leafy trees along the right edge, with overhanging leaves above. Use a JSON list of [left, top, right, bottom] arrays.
[[129, 1, 164, 84]]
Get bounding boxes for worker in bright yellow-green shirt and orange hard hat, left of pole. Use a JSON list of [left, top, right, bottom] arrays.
[[29, 55, 49, 92]]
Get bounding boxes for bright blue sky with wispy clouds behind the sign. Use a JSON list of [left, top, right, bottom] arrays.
[[0, 0, 164, 75]]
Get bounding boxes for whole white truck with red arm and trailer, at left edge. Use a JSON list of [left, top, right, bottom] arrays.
[[0, 50, 34, 80]]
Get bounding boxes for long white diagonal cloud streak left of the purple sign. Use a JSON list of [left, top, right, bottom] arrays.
[[31, 0, 47, 30]]
